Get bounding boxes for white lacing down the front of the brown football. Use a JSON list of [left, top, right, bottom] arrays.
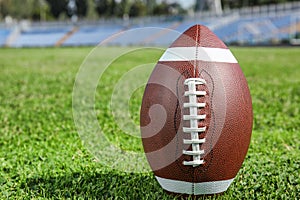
[[183, 78, 206, 167]]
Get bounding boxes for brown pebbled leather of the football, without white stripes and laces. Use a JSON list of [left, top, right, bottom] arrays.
[[140, 25, 253, 195]]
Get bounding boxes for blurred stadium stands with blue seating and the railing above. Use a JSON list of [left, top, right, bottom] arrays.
[[0, 1, 300, 47]]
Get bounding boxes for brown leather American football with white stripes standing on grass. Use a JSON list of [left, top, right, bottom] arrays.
[[140, 25, 253, 195]]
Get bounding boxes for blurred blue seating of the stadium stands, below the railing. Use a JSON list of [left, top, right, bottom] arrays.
[[0, 11, 300, 47]]
